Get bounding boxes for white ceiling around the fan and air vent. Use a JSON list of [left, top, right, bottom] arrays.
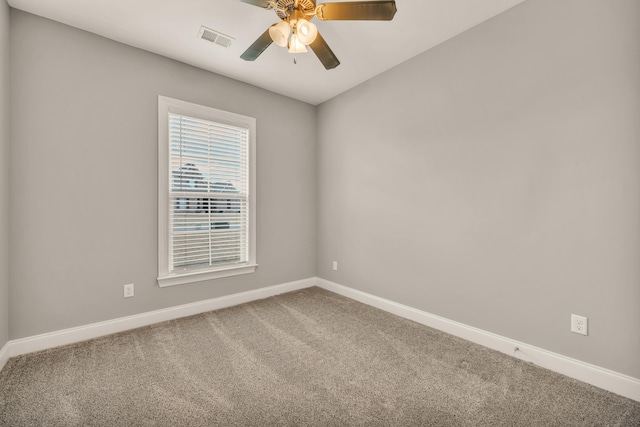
[[8, 0, 524, 105]]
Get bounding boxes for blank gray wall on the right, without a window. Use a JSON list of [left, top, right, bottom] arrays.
[[318, 0, 640, 378]]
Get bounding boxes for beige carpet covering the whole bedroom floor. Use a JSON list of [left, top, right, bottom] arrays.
[[0, 288, 640, 427]]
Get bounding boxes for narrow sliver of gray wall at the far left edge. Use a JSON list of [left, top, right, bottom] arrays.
[[0, 0, 9, 349]]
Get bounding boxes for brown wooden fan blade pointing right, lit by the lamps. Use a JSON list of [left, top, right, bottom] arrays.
[[316, 0, 398, 21]]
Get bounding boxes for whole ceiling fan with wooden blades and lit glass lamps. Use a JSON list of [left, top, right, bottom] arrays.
[[240, 0, 397, 70]]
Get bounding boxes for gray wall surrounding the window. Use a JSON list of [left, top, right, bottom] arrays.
[[9, 10, 316, 339]]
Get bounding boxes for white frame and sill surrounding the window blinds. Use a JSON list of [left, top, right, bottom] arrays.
[[158, 96, 258, 287]]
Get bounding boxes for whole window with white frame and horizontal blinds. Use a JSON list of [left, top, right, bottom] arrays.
[[158, 96, 256, 286]]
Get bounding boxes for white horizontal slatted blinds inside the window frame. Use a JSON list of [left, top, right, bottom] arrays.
[[168, 113, 249, 273]]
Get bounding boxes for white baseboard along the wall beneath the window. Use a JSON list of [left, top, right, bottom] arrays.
[[5, 277, 316, 362]]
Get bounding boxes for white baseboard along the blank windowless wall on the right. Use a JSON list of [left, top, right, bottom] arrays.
[[316, 278, 640, 402]]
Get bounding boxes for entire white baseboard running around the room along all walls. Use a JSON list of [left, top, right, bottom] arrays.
[[0, 278, 640, 402]]
